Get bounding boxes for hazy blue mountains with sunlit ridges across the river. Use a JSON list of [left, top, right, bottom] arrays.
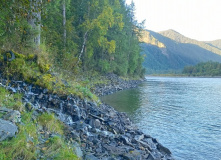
[[140, 30, 221, 73]]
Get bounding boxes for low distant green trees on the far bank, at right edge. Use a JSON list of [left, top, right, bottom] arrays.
[[183, 61, 221, 77]]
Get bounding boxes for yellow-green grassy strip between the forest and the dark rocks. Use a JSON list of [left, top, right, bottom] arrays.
[[0, 50, 98, 102]]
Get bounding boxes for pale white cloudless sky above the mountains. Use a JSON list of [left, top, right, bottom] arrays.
[[126, 0, 221, 41]]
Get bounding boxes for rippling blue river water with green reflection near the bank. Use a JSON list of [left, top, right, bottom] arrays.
[[102, 77, 221, 160]]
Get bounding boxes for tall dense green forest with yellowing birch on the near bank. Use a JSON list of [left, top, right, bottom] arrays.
[[0, 0, 144, 76]]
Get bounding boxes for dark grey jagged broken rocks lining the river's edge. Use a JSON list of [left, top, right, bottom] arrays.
[[0, 74, 173, 160]]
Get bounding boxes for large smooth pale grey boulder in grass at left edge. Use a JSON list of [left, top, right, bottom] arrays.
[[0, 119, 18, 142]]
